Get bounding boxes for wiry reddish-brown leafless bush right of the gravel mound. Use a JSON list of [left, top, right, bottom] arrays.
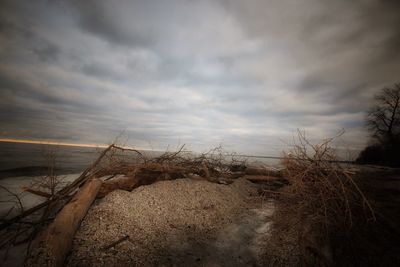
[[283, 131, 375, 227]]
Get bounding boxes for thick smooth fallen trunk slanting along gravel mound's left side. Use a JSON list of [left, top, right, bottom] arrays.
[[25, 179, 102, 266]]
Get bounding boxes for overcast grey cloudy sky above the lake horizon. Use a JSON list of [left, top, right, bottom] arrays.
[[0, 0, 400, 155]]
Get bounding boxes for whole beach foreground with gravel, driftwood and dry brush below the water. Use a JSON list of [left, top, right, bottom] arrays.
[[0, 142, 399, 266]]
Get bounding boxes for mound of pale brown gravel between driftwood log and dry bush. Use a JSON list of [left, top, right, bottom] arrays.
[[67, 179, 273, 266]]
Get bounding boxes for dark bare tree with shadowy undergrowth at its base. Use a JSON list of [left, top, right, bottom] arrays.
[[357, 83, 400, 167]]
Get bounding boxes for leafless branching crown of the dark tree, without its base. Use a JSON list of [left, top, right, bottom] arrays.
[[367, 83, 400, 142]]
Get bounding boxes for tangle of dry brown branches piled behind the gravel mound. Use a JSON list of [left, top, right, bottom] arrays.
[[96, 145, 245, 182]]
